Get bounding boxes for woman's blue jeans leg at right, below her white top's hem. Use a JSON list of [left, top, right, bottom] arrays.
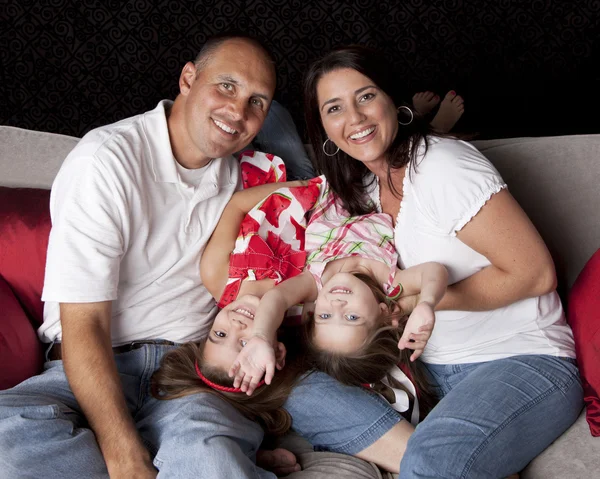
[[400, 355, 583, 479]]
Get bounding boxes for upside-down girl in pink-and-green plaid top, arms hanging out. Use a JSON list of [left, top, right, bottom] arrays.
[[230, 173, 447, 408]]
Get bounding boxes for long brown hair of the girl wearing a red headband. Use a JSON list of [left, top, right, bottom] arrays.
[[151, 339, 304, 435]]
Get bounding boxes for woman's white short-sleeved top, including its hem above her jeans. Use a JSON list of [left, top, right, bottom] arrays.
[[370, 138, 575, 364]]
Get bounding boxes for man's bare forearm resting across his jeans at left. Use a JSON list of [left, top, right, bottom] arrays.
[[61, 305, 151, 475]]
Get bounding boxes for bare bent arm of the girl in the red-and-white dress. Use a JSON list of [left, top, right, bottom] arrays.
[[200, 181, 307, 299]]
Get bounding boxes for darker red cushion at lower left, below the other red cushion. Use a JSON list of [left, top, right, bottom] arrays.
[[0, 277, 43, 389]]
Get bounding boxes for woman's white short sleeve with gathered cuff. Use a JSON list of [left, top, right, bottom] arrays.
[[409, 139, 506, 236]]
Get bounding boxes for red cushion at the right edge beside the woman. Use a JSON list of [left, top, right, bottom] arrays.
[[568, 250, 600, 436]]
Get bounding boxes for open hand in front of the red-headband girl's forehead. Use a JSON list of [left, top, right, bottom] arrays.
[[229, 336, 281, 396]]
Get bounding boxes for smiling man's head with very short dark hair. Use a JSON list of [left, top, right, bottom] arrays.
[[175, 39, 275, 167]]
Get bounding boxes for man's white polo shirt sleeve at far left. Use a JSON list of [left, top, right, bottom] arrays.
[[42, 155, 124, 303]]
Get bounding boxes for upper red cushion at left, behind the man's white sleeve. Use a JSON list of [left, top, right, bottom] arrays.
[[0, 187, 50, 325]]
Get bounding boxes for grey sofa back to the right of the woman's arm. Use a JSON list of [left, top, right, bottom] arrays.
[[473, 135, 600, 292]]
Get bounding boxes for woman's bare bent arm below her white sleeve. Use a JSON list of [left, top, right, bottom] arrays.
[[437, 190, 556, 311]]
